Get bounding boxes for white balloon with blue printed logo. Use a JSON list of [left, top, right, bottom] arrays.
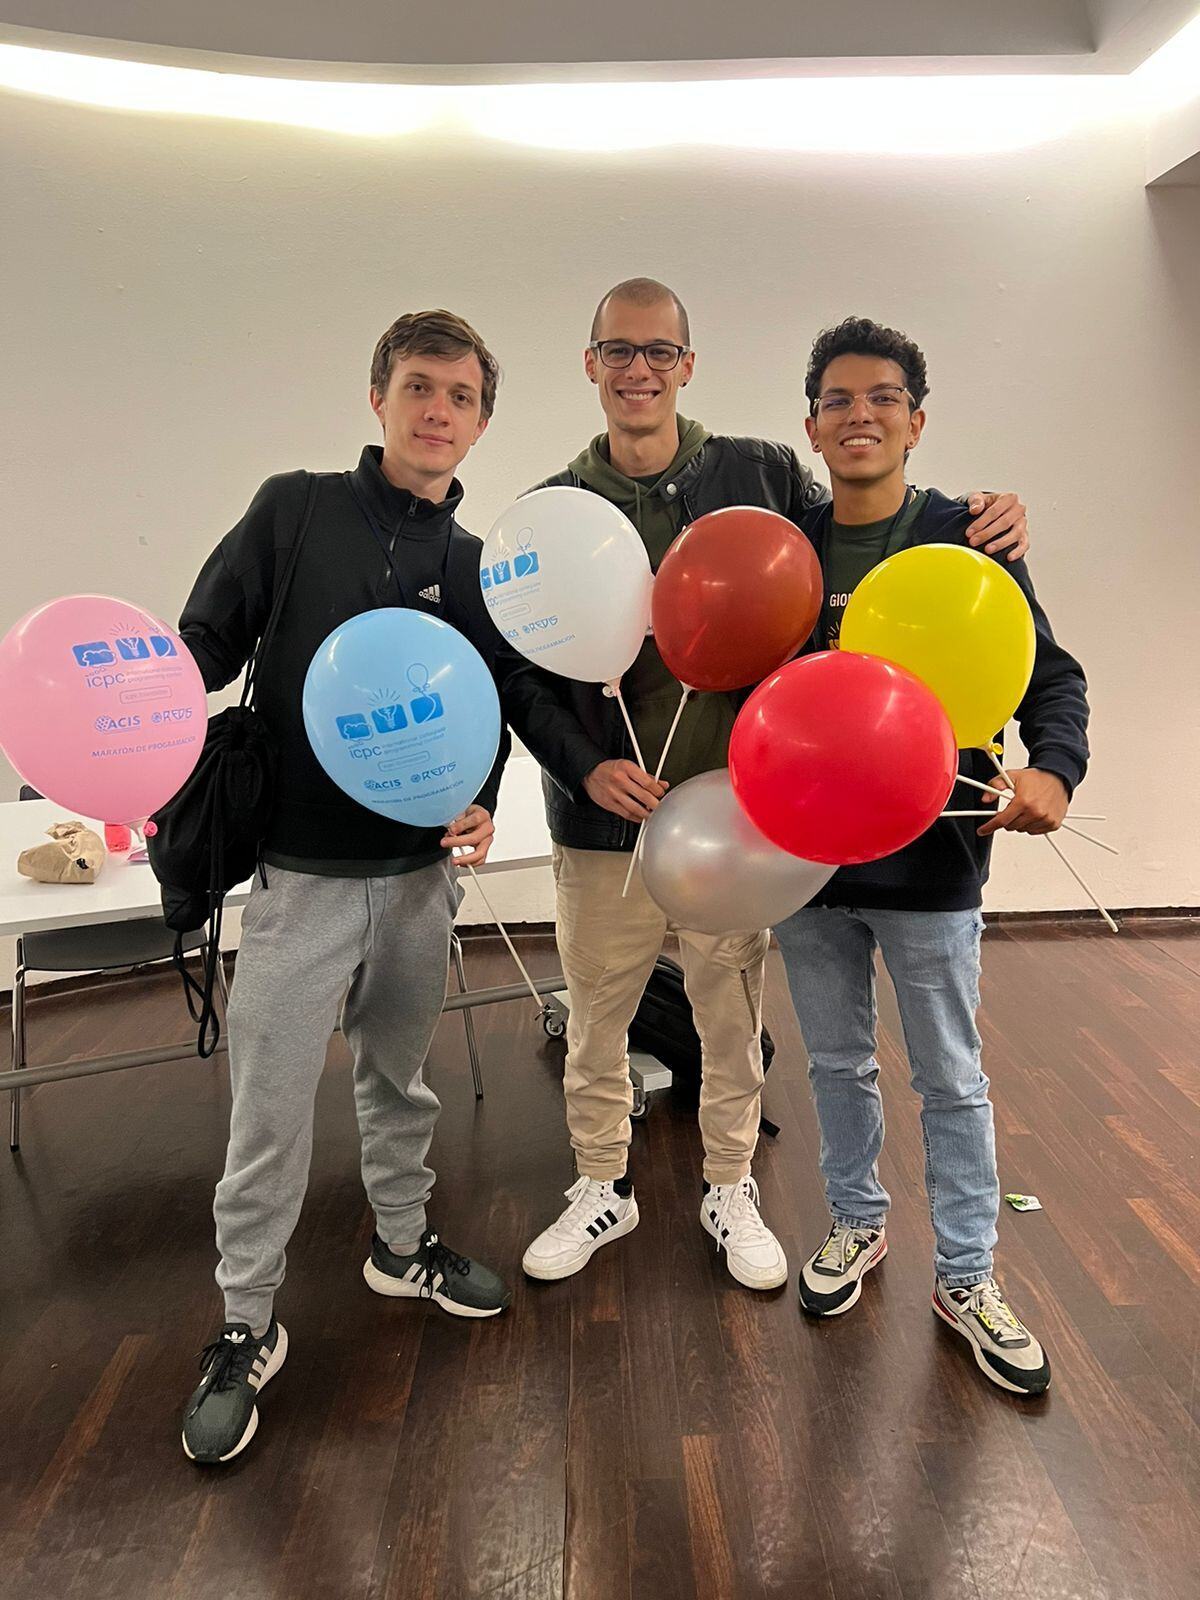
[[480, 488, 654, 683]]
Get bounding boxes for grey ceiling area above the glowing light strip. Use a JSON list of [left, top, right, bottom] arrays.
[[0, 0, 1198, 82]]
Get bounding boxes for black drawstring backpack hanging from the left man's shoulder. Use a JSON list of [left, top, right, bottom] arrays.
[[146, 475, 317, 1056]]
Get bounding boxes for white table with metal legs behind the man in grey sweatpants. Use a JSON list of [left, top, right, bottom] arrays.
[[0, 757, 565, 1098]]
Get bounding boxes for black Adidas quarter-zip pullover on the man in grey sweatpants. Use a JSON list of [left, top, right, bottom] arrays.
[[179, 445, 598, 861]]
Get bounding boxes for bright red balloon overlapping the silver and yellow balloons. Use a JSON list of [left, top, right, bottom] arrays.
[[730, 650, 958, 867]]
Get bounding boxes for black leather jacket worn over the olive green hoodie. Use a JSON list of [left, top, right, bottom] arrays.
[[531, 437, 829, 850]]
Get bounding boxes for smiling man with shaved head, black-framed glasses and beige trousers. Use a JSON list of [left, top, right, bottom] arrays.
[[523, 278, 1027, 1290]]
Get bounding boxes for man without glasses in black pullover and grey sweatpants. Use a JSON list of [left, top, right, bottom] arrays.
[[179, 310, 598, 1464]]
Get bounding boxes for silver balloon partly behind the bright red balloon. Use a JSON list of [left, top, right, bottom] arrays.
[[642, 766, 837, 933]]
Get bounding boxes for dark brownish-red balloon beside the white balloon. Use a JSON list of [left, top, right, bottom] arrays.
[[650, 506, 824, 690]]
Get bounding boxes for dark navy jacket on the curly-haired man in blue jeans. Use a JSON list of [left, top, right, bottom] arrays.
[[805, 490, 1088, 910]]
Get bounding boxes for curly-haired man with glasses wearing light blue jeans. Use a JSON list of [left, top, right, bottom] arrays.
[[776, 318, 1088, 1395]]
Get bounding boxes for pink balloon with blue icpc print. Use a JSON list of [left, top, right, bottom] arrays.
[[0, 595, 208, 822]]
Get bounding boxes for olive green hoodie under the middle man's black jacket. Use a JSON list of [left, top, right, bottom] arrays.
[[570, 416, 738, 784]]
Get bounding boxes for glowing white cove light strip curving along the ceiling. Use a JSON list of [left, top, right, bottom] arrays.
[[0, 18, 1200, 157]]
